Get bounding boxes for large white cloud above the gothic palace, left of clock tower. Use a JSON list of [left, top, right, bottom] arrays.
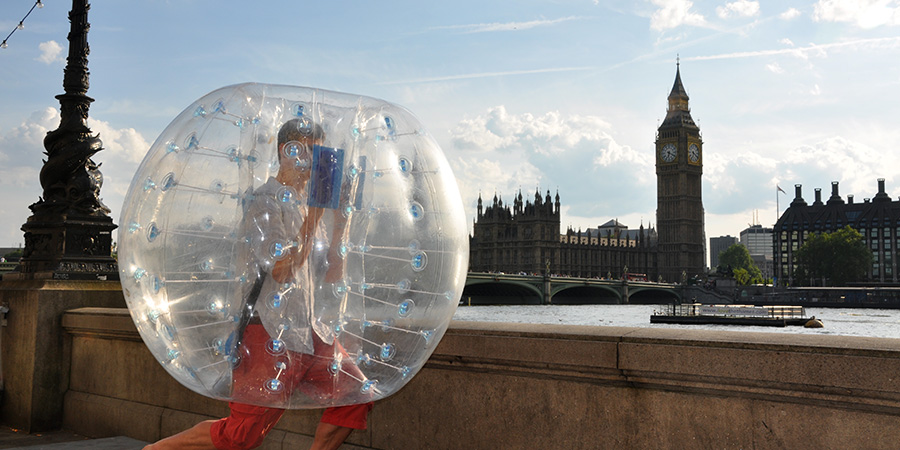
[[450, 106, 656, 230]]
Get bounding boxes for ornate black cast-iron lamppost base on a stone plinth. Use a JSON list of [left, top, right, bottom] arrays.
[[20, 0, 118, 280]]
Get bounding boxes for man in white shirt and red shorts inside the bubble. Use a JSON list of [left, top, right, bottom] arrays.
[[144, 118, 372, 450]]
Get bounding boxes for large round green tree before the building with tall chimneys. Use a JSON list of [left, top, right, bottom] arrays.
[[795, 225, 872, 286]]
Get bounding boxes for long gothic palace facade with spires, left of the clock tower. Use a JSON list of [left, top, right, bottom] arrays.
[[469, 191, 658, 280]]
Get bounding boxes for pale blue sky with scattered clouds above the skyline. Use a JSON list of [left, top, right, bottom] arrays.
[[0, 0, 900, 264]]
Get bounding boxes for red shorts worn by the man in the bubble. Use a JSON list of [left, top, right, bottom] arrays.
[[210, 324, 372, 450]]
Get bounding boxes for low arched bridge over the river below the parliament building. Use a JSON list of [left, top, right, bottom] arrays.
[[461, 272, 690, 305]]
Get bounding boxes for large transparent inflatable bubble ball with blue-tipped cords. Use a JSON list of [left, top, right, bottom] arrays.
[[118, 83, 468, 408]]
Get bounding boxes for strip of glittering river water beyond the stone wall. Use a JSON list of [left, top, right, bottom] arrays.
[[453, 305, 900, 339]]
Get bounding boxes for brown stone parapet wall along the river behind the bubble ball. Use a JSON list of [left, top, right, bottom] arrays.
[[63, 308, 900, 450]]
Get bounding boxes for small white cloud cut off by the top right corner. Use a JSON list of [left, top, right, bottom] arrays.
[[813, 0, 900, 29]]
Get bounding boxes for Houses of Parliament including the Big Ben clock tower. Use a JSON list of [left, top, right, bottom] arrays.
[[469, 64, 706, 283]]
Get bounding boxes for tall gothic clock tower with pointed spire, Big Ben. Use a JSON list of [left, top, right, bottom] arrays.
[[656, 62, 706, 283]]
